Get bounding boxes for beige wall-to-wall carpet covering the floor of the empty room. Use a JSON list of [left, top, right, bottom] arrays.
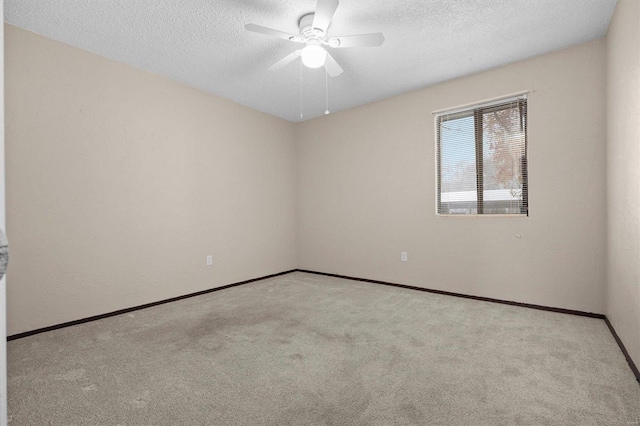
[[8, 272, 640, 426]]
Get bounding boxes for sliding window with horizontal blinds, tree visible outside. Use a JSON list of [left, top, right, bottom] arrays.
[[436, 96, 529, 215]]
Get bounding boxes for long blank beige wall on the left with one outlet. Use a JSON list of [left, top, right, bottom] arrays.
[[5, 25, 296, 334]]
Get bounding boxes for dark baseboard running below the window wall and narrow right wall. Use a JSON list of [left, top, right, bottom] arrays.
[[297, 269, 640, 383]]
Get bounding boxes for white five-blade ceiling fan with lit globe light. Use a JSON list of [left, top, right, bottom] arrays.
[[244, 0, 384, 77]]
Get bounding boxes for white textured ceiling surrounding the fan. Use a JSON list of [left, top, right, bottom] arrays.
[[5, 0, 616, 122]]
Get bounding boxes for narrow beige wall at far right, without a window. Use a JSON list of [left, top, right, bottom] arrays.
[[607, 0, 640, 366]]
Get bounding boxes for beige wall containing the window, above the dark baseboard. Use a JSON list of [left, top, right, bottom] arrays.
[[296, 40, 606, 313]]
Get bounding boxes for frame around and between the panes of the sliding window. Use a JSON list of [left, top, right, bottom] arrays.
[[432, 95, 529, 217]]
